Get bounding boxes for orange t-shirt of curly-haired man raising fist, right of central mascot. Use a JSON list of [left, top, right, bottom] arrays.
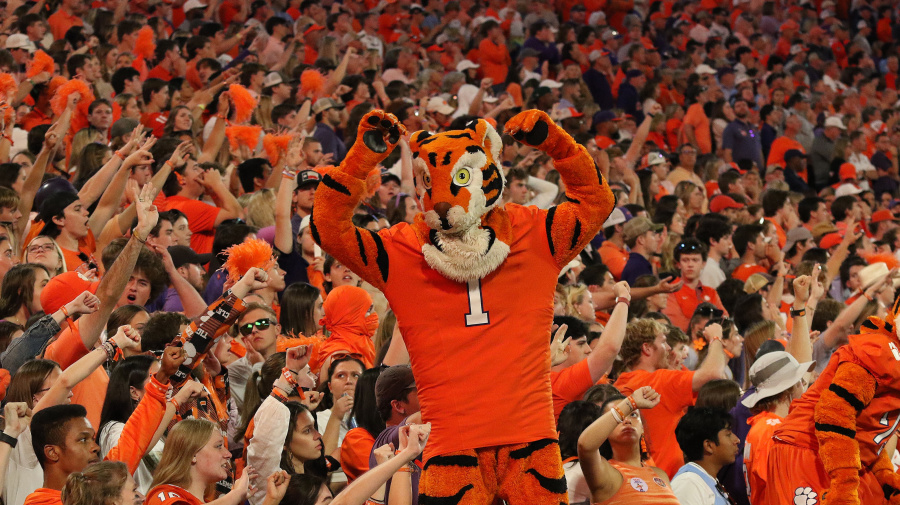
[[615, 369, 696, 479]]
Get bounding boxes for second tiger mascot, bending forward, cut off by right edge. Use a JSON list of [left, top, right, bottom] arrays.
[[765, 292, 900, 505]]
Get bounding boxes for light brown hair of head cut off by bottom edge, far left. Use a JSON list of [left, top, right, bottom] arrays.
[[61, 461, 128, 505]]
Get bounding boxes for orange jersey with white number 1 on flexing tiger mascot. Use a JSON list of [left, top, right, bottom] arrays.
[[379, 204, 559, 461]]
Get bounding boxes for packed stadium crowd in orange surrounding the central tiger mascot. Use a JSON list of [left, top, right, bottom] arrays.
[[0, 0, 900, 505]]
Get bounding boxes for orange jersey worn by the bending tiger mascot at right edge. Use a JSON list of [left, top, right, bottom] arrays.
[[775, 328, 900, 468]]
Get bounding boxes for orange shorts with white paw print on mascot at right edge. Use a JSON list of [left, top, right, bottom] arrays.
[[765, 440, 887, 505]]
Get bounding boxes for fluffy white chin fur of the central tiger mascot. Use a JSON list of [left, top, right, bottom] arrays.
[[422, 227, 509, 282]]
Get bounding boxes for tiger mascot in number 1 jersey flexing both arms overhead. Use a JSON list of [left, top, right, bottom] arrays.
[[310, 110, 615, 505]]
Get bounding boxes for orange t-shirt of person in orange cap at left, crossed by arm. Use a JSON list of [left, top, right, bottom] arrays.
[[44, 321, 109, 426]]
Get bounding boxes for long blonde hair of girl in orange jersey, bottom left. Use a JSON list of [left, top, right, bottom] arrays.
[[150, 419, 218, 488]]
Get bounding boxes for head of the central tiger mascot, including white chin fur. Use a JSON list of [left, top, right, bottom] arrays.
[[410, 119, 509, 281]]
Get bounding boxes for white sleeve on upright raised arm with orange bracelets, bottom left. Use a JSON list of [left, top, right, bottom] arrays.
[[247, 396, 291, 505]]
